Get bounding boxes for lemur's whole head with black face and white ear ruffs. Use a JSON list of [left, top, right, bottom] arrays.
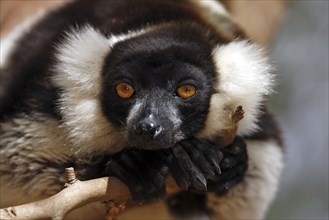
[[53, 24, 272, 155]]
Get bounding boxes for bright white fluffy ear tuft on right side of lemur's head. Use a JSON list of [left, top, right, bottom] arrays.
[[213, 41, 273, 98]]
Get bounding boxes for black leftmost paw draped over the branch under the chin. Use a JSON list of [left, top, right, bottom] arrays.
[[106, 149, 167, 202]]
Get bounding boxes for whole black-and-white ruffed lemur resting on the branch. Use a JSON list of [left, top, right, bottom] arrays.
[[0, 0, 283, 219]]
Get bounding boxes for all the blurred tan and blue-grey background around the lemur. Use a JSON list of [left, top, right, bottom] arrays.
[[0, 0, 329, 220]]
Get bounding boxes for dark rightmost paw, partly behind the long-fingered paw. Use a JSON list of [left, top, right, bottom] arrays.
[[207, 137, 248, 194]]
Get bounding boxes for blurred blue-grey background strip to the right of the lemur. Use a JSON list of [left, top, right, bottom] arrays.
[[268, 0, 329, 220]]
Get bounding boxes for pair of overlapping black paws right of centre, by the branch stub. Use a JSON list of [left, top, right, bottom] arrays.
[[167, 137, 248, 193]]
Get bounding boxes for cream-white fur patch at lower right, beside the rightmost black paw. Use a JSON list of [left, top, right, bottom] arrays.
[[208, 141, 284, 219]]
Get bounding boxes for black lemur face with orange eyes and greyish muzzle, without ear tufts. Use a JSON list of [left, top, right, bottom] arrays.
[[102, 32, 214, 149]]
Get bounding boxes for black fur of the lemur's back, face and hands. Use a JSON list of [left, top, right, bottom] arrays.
[[0, 0, 258, 217]]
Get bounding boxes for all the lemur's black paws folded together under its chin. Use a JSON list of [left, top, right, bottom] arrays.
[[105, 137, 247, 202]]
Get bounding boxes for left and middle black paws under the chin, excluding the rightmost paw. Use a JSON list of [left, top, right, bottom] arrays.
[[105, 138, 219, 202]]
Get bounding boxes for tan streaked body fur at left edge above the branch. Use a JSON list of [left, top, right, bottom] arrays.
[[0, 115, 70, 207]]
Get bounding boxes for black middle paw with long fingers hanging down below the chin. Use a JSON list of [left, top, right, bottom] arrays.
[[167, 138, 223, 191]]
